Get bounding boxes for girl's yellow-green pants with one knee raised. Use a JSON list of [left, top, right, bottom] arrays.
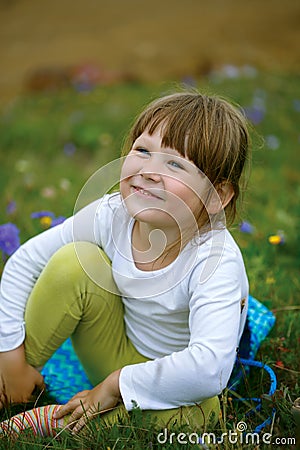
[[25, 242, 219, 428]]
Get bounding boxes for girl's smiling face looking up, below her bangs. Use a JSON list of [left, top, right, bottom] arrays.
[[120, 127, 207, 230]]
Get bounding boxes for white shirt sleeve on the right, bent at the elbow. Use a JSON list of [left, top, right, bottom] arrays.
[[120, 246, 248, 410]]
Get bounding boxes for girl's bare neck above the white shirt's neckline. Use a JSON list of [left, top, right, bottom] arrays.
[[131, 221, 188, 271]]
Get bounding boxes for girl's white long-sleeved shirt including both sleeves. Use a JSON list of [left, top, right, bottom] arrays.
[[0, 194, 248, 410]]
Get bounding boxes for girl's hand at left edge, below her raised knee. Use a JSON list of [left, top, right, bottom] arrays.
[[0, 345, 45, 409]]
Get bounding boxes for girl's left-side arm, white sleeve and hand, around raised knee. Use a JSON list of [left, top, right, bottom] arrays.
[[0, 201, 104, 407]]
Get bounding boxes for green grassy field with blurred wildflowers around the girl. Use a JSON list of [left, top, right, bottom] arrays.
[[0, 68, 300, 449]]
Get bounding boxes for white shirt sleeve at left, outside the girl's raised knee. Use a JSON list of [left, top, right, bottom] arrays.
[[0, 200, 108, 352]]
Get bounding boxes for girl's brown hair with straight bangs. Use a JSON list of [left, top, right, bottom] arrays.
[[123, 91, 250, 223]]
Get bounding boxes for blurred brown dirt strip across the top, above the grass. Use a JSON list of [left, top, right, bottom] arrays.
[[0, 0, 300, 105]]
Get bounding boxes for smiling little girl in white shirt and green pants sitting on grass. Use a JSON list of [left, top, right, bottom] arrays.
[[0, 92, 249, 434]]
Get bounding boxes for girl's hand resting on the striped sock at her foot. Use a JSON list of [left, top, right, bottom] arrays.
[[54, 369, 121, 433]]
